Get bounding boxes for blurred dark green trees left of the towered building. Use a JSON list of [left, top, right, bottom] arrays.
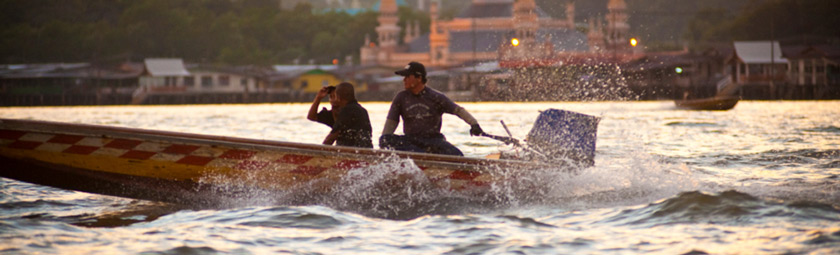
[[0, 0, 429, 65]]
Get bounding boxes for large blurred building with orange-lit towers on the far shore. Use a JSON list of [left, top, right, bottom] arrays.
[[360, 0, 592, 68]]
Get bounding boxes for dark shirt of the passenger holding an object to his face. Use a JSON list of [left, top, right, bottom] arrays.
[[332, 100, 373, 148]]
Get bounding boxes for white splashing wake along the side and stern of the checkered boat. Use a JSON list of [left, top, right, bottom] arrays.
[[194, 149, 699, 219]]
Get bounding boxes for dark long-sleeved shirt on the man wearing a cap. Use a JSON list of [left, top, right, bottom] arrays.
[[388, 87, 458, 137]]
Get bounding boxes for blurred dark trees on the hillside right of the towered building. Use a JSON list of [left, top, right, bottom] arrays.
[[537, 0, 840, 50]]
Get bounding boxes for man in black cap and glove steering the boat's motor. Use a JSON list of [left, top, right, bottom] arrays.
[[379, 62, 484, 156]]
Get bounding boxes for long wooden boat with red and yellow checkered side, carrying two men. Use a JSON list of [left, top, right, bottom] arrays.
[[0, 110, 598, 206]]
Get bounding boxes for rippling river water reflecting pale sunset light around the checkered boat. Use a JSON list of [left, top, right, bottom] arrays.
[[0, 101, 840, 254]]
